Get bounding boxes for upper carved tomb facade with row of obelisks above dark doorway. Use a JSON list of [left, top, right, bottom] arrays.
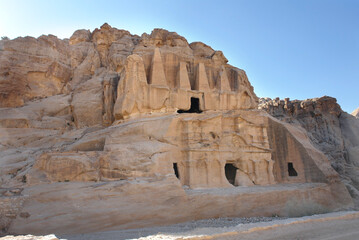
[[114, 34, 257, 119]]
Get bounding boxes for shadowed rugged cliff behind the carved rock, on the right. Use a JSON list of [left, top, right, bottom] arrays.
[[259, 96, 359, 206]]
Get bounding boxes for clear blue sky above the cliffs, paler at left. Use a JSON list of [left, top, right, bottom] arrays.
[[0, 0, 359, 112]]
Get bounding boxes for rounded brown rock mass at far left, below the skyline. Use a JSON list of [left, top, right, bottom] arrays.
[[0, 35, 72, 107]]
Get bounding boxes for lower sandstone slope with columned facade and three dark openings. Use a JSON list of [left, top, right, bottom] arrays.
[[2, 110, 351, 234]]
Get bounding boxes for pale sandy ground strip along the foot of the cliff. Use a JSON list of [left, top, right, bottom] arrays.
[[60, 211, 359, 240]]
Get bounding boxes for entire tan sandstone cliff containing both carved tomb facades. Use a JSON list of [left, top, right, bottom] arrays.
[[0, 24, 353, 234]]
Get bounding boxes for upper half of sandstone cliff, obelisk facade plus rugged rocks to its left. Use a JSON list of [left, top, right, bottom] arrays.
[[0, 24, 257, 123]]
